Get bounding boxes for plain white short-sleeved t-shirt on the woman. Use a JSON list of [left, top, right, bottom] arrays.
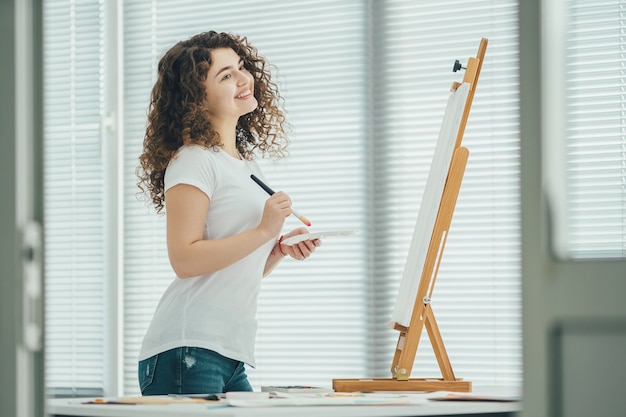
[[139, 146, 275, 366]]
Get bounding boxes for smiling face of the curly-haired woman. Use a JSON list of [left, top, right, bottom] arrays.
[[205, 48, 257, 124]]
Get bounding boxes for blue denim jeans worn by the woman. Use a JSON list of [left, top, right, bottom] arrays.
[[138, 347, 252, 395]]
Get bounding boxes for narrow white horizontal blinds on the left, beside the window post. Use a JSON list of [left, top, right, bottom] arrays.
[[43, 0, 106, 395]]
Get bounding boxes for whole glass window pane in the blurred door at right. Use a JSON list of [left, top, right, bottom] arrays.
[[544, 0, 626, 259]]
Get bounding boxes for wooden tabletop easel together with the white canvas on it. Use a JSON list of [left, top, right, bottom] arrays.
[[333, 38, 487, 392]]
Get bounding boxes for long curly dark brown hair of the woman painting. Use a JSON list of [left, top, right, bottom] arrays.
[[137, 31, 288, 213]]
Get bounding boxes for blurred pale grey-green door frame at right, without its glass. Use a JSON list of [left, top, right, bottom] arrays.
[[520, 0, 626, 417]]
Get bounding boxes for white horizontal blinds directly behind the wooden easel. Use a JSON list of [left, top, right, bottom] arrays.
[[373, 0, 521, 387]]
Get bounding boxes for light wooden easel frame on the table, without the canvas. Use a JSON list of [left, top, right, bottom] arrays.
[[333, 38, 487, 392]]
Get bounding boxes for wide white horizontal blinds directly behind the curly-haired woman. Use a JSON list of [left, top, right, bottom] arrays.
[[119, 1, 369, 394]]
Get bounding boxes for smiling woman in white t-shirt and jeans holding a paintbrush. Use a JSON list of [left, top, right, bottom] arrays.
[[138, 32, 320, 395]]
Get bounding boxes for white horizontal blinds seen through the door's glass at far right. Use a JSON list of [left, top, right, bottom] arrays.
[[565, 0, 626, 258]]
